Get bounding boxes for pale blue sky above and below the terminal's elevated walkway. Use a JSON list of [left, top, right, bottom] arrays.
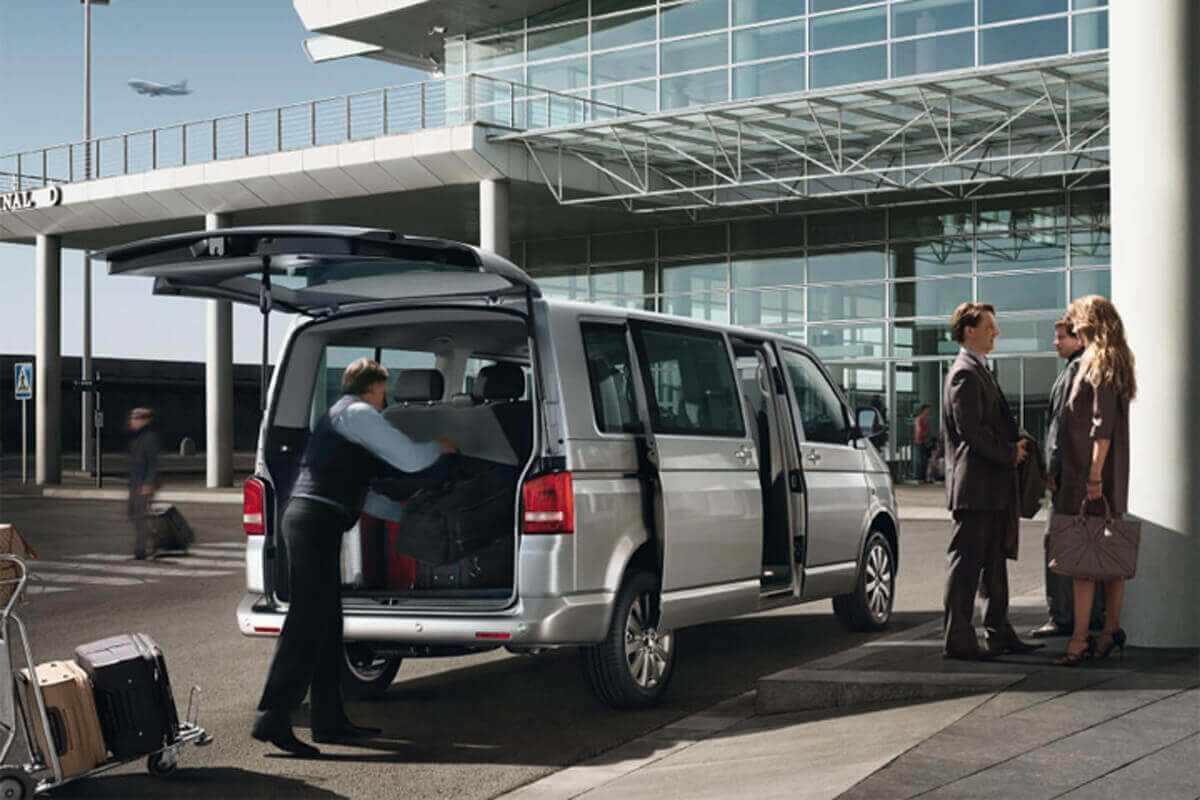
[[0, 0, 427, 363]]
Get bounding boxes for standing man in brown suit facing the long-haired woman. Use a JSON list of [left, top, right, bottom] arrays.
[[942, 302, 1042, 660]]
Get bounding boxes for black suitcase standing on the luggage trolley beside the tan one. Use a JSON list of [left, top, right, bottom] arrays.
[[76, 633, 179, 760]]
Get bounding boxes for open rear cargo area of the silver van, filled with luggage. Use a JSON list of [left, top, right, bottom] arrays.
[[264, 306, 534, 612]]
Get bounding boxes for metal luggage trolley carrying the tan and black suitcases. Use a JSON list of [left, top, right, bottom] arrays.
[[0, 554, 212, 800]]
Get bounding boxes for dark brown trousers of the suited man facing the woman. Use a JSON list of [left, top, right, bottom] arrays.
[[943, 511, 1016, 654]]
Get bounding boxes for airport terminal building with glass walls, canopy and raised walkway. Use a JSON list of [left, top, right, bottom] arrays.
[[0, 0, 1111, 482]]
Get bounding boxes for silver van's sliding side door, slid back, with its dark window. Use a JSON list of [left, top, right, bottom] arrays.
[[634, 323, 762, 630]]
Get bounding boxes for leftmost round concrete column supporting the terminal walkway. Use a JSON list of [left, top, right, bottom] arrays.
[[34, 234, 62, 486]]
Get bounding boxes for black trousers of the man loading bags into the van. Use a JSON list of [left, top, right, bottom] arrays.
[[258, 498, 346, 730]]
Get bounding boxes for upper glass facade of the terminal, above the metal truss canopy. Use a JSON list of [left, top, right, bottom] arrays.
[[445, 0, 1109, 113]]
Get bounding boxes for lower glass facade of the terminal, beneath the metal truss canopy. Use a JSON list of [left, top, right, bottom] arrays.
[[512, 187, 1111, 477]]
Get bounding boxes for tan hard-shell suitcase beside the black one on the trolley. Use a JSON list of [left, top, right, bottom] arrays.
[[18, 661, 108, 777]]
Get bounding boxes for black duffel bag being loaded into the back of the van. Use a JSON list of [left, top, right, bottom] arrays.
[[395, 455, 520, 564]]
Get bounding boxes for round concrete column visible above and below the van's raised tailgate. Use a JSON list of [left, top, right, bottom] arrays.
[[204, 213, 233, 487]]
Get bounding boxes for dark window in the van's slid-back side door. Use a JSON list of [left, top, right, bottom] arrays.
[[640, 327, 745, 437]]
